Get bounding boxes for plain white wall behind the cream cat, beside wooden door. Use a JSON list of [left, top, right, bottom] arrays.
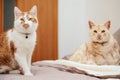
[[58, 0, 120, 58]]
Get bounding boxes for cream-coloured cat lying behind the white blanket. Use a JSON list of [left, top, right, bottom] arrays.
[[69, 21, 120, 65]]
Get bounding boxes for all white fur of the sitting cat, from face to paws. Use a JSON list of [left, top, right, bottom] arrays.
[[7, 6, 38, 75]]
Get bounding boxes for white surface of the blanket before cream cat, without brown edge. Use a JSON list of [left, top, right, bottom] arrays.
[[43, 59, 120, 76]]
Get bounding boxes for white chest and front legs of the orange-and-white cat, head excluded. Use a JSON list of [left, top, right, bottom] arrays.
[[7, 30, 36, 75]]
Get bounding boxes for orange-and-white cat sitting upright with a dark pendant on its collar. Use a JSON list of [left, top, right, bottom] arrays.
[[0, 6, 38, 75]]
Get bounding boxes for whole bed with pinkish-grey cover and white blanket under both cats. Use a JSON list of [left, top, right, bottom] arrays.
[[0, 29, 120, 80]]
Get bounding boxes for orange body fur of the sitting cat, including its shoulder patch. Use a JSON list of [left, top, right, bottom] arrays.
[[0, 28, 20, 73]]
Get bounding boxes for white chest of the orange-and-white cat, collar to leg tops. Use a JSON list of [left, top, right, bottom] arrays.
[[7, 30, 36, 54]]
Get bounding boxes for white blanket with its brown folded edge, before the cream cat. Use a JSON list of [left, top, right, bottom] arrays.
[[41, 60, 120, 79]]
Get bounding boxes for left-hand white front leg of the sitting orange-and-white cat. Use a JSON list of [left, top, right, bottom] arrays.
[[15, 53, 33, 76]]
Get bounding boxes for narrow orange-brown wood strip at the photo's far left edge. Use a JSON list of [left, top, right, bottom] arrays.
[[0, 0, 4, 33]]
